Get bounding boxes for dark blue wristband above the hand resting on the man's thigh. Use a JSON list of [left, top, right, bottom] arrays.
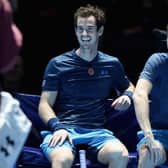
[[47, 117, 66, 132]]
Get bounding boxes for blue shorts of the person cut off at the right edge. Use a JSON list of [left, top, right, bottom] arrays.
[[137, 130, 168, 152]]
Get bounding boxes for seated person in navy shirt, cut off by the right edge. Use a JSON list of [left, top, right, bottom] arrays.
[[133, 26, 168, 168]]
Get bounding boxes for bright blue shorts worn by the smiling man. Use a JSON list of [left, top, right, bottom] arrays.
[[40, 128, 119, 159]]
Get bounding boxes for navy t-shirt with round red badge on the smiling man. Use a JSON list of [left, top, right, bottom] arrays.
[[42, 50, 129, 128]]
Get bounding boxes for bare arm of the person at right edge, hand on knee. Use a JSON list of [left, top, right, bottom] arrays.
[[133, 79, 164, 163]]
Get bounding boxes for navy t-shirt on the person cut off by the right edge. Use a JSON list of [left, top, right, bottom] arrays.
[[140, 53, 168, 129]]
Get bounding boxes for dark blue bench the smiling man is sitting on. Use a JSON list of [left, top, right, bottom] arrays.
[[14, 93, 138, 168]]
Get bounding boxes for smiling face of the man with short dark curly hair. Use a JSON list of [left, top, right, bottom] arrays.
[[75, 16, 100, 48]]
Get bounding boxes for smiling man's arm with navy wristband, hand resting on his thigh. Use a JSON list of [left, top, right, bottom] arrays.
[[39, 91, 72, 146]]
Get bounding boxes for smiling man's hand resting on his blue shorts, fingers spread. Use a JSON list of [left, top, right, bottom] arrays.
[[49, 129, 72, 146]]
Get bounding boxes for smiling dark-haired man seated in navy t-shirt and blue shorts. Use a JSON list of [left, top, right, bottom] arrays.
[[39, 5, 134, 168]]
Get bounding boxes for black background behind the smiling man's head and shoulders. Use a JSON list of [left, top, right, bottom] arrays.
[[14, 0, 168, 94]]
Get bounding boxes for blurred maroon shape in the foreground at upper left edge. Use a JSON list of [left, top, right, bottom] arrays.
[[0, 0, 23, 74]]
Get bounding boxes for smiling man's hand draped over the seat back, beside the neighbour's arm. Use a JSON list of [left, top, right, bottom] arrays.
[[111, 95, 131, 111]]
